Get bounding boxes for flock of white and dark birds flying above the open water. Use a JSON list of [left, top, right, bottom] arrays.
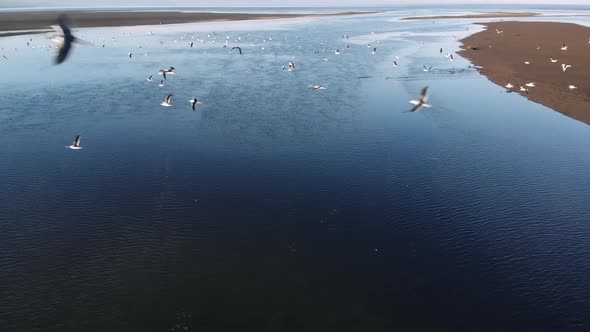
[[42, 14, 454, 150]]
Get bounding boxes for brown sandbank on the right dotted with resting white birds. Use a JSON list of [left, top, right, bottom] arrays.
[[459, 22, 590, 124]]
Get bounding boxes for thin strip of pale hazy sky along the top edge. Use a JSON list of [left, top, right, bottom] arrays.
[[0, 0, 590, 7]]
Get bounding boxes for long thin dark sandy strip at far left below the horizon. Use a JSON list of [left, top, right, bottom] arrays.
[[0, 11, 373, 36]]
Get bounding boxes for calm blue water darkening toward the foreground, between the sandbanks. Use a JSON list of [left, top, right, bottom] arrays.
[[0, 7, 590, 331]]
